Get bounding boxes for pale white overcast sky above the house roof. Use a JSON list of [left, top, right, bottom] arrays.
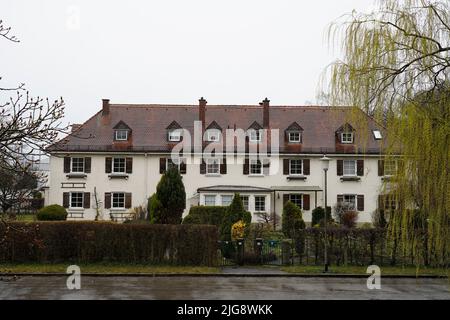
[[0, 0, 374, 123]]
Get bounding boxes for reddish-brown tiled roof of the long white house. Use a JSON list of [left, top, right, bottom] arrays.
[[49, 104, 383, 153]]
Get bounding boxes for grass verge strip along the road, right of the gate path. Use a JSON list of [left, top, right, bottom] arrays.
[[281, 266, 450, 277]]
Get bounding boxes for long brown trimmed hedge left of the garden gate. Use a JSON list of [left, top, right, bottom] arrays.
[[0, 221, 218, 266]]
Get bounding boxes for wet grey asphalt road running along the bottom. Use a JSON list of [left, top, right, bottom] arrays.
[[0, 276, 450, 300]]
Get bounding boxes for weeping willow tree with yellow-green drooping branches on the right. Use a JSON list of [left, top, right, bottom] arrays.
[[326, 0, 450, 266]]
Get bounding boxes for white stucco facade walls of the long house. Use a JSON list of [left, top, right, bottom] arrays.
[[47, 152, 382, 223]]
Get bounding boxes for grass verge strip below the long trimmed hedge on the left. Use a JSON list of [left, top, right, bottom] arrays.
[[0, 263, 220, 274]]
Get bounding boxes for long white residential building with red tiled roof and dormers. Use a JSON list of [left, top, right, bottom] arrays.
[[49, 98, 394, 223]]
